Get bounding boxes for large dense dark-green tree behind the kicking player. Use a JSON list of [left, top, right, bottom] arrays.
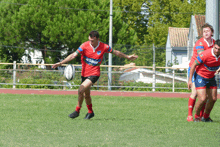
[[0, 0, 137, 63]]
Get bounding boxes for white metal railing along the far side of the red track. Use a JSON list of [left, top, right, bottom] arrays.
[[0, 61, 187, 92]]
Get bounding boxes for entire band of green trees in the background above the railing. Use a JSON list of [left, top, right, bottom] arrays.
[[0, 0, 205, 66]]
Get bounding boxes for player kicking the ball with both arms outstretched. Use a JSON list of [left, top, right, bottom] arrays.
[[52, 31, 138, 119]]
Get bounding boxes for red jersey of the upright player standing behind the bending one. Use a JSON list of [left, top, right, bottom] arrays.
[[189, 38, 215, 67]]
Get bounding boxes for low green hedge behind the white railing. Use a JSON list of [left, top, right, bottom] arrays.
[[0, 69, 190, 92]]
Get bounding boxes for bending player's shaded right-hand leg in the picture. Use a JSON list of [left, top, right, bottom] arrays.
[[202, 88, 217, 122]]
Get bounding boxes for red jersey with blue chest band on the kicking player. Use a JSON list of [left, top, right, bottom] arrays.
[[76, 41, 113, 77]]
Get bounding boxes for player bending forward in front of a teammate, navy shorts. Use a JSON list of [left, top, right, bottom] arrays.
[[188, 40, 220, 122]]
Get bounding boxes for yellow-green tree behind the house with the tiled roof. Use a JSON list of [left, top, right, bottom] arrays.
[[141, 0, 205, 66]]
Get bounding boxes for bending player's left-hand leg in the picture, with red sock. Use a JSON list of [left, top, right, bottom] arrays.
[[194, 89, 207, 121]]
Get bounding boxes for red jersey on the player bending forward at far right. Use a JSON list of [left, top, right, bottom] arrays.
[[195, 49, 220, 79]]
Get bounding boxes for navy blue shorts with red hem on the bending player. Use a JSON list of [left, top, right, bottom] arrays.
[[195, 73, 217, 89]]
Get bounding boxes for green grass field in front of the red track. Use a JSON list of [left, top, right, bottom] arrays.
[[0, 94, 220, 147]]
